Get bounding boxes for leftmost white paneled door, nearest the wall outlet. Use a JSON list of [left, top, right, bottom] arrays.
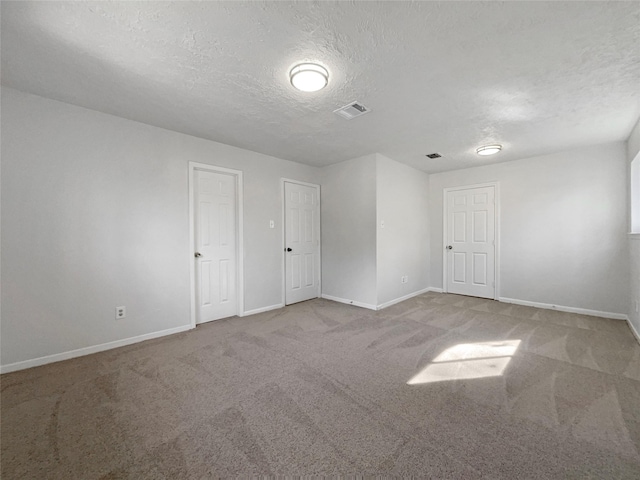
[[194, 170, 238, 323]]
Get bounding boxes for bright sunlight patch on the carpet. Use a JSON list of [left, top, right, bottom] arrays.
[[407, 340, 520, 385]]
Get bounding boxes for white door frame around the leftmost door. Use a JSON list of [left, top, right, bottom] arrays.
[[187, 162, 244, 328]]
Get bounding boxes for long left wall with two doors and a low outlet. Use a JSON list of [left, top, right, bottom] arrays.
[[0, 87, 320, 366]]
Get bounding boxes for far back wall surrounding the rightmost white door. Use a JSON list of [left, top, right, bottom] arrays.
[[429, 143, 629, 314]]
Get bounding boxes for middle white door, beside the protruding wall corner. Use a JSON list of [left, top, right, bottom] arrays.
[[284, 182, 320, 305]]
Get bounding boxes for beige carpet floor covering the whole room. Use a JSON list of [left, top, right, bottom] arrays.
[[1, 293, 640, 480]]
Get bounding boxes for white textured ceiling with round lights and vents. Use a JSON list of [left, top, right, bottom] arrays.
[[2, 1, 640, 172]]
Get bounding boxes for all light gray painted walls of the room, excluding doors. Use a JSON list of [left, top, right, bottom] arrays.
[[0, 88, 640, 372]]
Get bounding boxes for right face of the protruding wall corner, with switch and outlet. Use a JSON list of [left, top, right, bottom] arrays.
[[376, 155, 430, 305]]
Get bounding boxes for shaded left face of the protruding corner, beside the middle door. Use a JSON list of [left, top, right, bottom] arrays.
[[321, 154, 377, 308]]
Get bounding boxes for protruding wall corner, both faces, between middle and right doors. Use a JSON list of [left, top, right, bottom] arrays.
[[322, 154, 429, 308]]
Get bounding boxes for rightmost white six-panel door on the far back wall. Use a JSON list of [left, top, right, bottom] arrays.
[[444, 186, 496, 298]]
